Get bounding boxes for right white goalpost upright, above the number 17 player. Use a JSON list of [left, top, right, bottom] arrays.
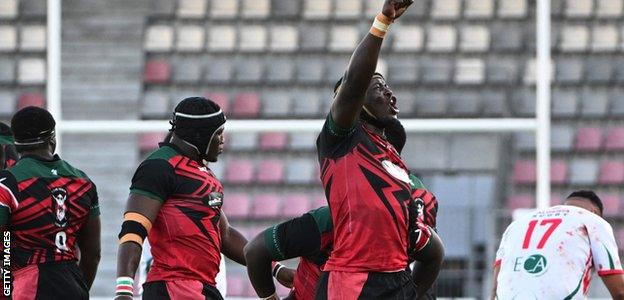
[[535, 0, 551, 209]]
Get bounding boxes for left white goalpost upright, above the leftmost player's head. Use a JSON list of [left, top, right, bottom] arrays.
[[46, 0, 63, 153]]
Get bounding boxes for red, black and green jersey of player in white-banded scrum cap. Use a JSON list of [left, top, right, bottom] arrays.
[[130, 144, 223, 286]]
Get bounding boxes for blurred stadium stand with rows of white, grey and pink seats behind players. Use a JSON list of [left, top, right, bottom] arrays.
[[0, 0, 624, 298]]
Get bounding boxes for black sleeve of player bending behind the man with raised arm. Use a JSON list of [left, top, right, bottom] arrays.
[[263, 213, 321, 261]]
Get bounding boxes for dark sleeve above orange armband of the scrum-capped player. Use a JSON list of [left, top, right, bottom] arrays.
[[130, 159, 175, 203]]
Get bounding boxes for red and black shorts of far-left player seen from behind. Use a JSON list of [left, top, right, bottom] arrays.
[[13, 261, 89, 300]]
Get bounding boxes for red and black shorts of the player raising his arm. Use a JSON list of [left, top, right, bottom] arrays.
[[316, 271, 417, 300]]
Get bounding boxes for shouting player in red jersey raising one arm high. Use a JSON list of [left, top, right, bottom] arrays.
[[316, 0, 424, 299]]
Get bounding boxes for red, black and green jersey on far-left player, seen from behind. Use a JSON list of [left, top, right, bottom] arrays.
[[0, 156, 100, 269]]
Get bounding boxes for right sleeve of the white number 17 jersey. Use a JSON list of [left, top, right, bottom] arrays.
[[586, 216, 624, 276]]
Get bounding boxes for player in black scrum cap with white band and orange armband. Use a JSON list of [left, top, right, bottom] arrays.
[[116, 97, 247, 299]]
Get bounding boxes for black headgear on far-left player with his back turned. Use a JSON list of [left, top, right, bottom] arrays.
[[11, 106, 56, 151]]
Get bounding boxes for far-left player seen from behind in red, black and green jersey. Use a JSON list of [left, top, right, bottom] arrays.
[[0, 106, 100, 299]]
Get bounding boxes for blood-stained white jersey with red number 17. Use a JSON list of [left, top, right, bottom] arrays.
[[495, 205, 624, 300]]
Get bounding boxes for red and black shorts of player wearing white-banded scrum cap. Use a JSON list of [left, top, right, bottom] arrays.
[[143, 280, 223, 300]]
